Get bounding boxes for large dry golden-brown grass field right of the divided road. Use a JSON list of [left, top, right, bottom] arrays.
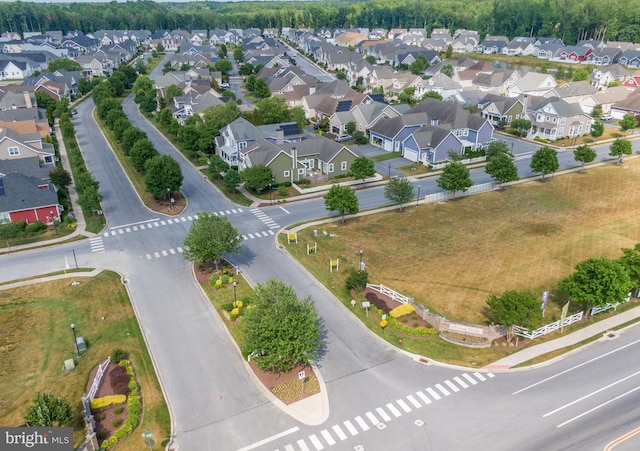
[[279, 160, 640, 363]]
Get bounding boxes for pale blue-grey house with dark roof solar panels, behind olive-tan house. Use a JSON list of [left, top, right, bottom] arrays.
[[214, 117, 303, 166]]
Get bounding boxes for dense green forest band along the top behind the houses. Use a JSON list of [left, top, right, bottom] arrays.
[[0, 0, 640, 44]]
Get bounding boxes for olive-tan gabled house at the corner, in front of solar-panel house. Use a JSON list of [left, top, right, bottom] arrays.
[[238, 137, 360, 184]]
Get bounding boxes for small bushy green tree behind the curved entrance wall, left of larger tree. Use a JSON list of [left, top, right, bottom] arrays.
[[487, 291, 542, 341]]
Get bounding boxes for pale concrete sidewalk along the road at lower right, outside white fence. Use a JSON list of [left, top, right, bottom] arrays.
[[483, 306, 640, 371]]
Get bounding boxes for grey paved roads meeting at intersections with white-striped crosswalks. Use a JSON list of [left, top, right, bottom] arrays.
[[0, 99, 640, 450]]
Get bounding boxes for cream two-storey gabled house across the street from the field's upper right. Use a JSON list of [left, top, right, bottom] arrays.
[[526, 97, 591, 140]]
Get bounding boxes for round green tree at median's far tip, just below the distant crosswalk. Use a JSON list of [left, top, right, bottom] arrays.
[[183, 211, 242, 269]]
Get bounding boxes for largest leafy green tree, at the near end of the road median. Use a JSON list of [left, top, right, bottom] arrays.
[[243, 279, 322, 372]]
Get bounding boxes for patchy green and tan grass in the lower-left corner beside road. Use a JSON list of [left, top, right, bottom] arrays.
[[0, 272, 170, 450]]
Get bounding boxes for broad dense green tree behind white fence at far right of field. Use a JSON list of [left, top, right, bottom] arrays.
[[559, 257, 633, 309]]
